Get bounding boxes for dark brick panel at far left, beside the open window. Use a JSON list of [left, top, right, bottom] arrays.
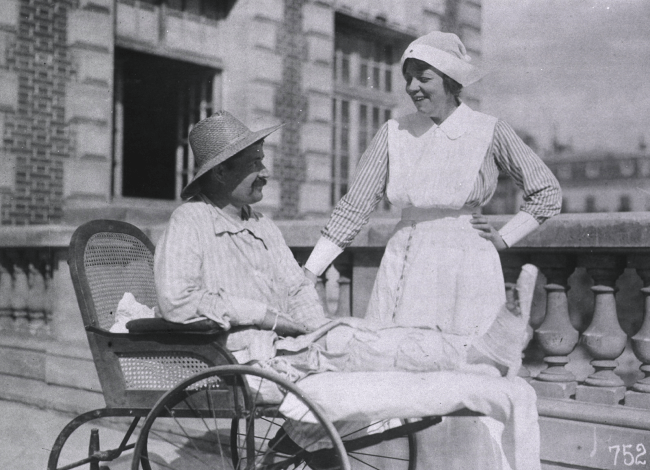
[[1, 0, 77, 225]]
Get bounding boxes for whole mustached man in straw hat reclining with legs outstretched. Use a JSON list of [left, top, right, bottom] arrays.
[[154, 111, 540, 470]]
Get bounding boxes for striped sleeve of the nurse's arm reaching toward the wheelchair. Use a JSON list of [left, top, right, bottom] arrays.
[[322, 124, 388, 248]]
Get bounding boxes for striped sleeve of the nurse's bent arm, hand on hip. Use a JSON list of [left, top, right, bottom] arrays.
[[492, 120, 562, 224]]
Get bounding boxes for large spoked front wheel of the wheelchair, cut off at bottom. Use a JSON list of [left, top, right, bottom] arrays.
[[131, 365, 351, 470]]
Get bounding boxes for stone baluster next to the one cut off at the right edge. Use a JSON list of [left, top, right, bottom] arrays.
[[576, 255, 627, 405]]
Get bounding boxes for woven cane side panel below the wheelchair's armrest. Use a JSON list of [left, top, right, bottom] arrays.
[[119, 354, 209, 390]]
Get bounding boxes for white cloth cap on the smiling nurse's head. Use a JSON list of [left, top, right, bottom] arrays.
[[401, 31, 485, 86]]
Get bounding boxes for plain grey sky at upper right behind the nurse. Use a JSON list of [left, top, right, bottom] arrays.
[[479, 0, 650, 152]]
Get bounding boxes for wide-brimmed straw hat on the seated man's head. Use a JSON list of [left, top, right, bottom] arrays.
[[181, 111, 283, 199]]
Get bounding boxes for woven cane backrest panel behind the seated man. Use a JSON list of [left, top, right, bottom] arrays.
[[84, 232, 157, 330]]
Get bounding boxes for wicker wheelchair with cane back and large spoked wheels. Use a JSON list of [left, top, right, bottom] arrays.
[[48, 220, 450, 470]]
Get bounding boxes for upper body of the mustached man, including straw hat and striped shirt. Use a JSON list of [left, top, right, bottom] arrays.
[[154, 111, 328, 363]]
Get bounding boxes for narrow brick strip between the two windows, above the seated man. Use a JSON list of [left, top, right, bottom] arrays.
[[274, 0, 307, 218]]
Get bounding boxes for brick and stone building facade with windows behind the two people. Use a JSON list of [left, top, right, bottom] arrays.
[[0, 0, 481, 225]]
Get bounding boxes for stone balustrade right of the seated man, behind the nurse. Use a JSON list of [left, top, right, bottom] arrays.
[[282, 213, 650, 409]]
